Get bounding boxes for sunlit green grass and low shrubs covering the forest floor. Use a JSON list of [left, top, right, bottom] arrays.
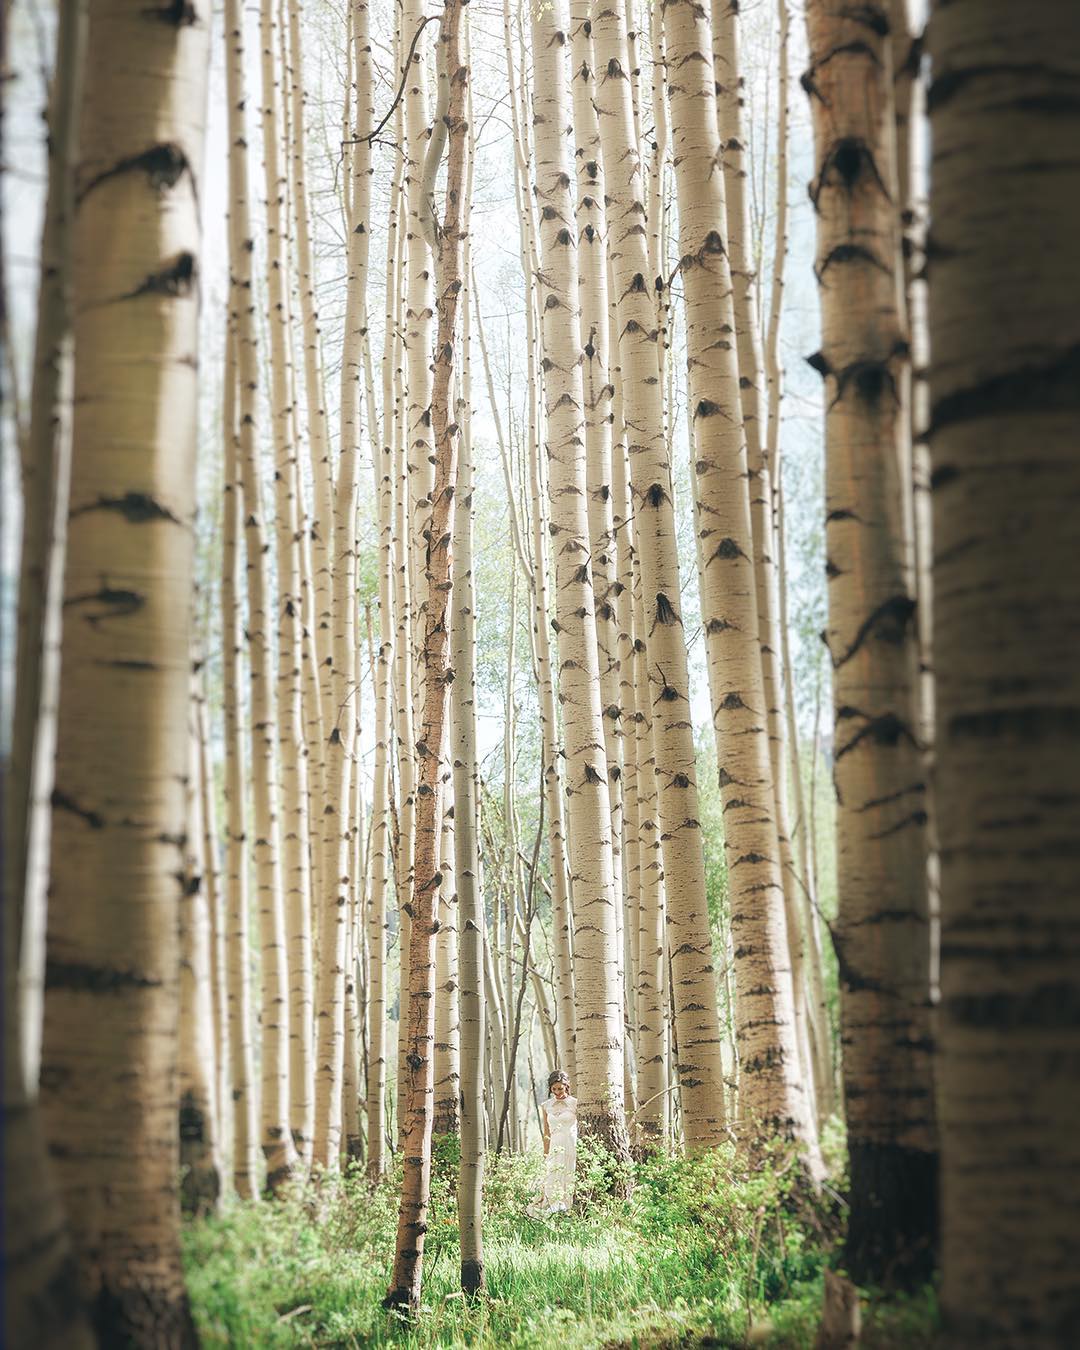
[[184, 1139, 936, 1350]]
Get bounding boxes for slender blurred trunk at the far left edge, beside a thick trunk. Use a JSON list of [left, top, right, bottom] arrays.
[[0, 21, 87, 1306]]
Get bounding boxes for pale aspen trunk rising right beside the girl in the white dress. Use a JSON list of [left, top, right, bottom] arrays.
[[532, 0, 626, 1153]]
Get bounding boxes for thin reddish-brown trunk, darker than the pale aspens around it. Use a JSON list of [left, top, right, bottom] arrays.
[[385, 0, 468, 1316]]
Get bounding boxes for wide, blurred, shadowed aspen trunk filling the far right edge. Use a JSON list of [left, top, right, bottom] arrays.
[[927, 0, 1080, 1333]]
